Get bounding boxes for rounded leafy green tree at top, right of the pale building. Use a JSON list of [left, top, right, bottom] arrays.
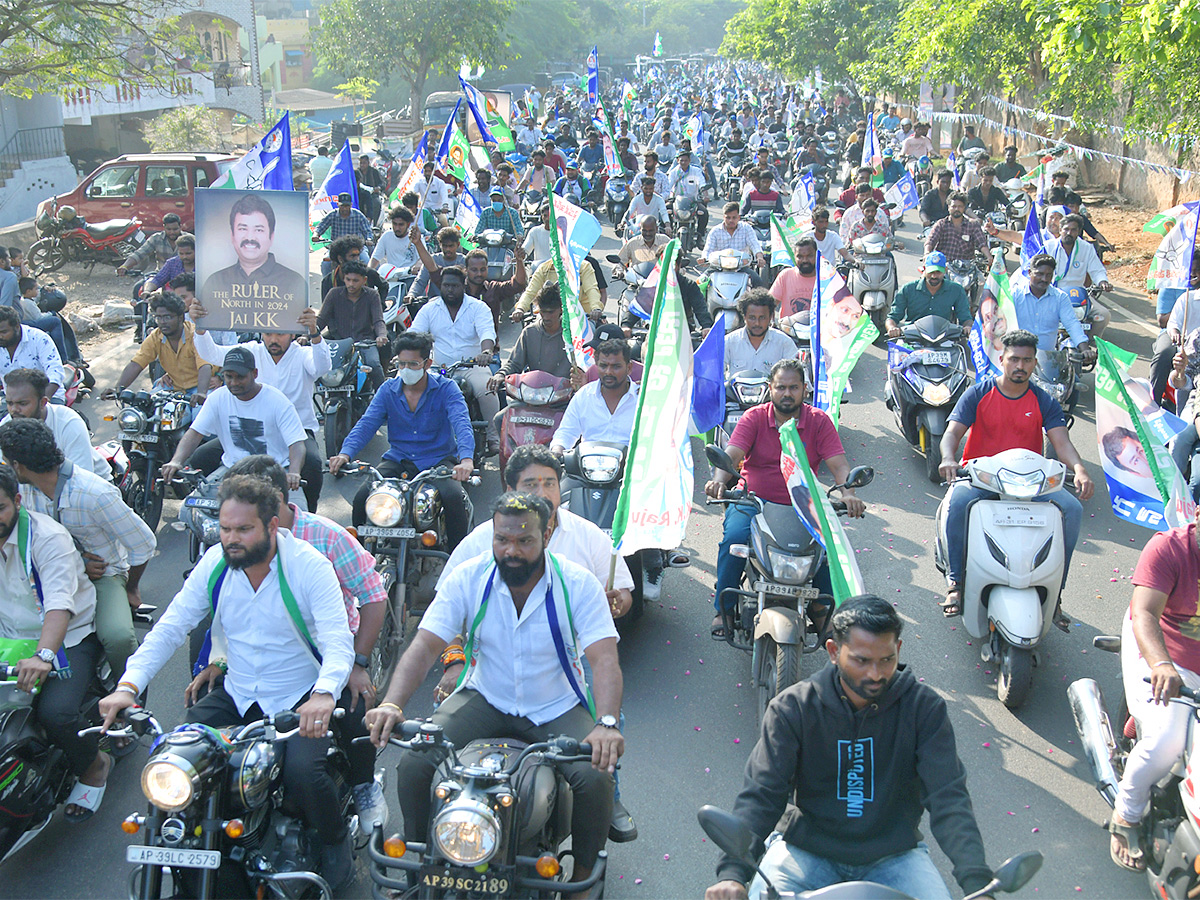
[[312, 0, 515, 110]]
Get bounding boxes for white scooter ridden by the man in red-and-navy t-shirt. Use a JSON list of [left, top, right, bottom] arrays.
[[934, 449, 1069, 709]]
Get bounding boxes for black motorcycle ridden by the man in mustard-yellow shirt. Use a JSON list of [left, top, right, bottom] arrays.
[[104, 388, 192, 530]]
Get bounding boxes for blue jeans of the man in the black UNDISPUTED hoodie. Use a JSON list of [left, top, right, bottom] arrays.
[[750, 832, 950, 900]]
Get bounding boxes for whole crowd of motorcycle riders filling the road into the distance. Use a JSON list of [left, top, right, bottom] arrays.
[[0, 52, 1185, 900]]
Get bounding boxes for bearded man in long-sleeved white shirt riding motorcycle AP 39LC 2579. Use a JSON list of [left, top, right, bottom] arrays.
[[100, 475, 354, 890]]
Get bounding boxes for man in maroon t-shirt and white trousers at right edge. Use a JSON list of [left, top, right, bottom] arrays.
[[1109, 517, 1200, 870]]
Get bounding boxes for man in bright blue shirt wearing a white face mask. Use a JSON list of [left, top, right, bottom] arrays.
[[329, 331, 475, 551]]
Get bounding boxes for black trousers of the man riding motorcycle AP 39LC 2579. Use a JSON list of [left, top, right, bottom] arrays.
[[186, 685, 346, 844]]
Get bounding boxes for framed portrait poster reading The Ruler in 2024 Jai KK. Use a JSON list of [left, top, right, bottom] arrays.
[[196, 188, 308, 334]]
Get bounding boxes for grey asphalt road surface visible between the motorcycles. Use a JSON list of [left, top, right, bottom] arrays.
[[0, 210, 1153, 899]]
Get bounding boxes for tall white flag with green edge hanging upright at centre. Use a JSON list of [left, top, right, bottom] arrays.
[[612, 240, 694, 556]]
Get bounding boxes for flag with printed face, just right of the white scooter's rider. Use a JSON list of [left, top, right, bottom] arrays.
[[1096, 338, 1195, 532]]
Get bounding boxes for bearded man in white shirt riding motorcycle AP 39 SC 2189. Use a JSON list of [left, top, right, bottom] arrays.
[[366, 493, 625, 881]]
